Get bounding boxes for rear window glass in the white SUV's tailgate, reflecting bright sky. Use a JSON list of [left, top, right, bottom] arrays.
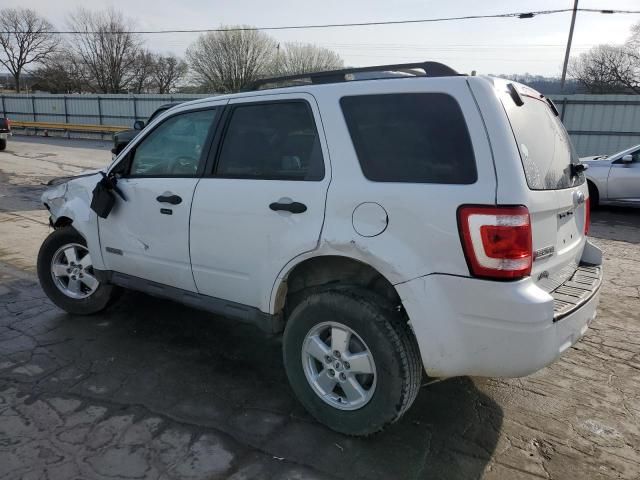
[[501, 85, 584, 190]]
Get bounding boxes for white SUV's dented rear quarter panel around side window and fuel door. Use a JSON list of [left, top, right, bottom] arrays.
[[269, 77, 496, 312]]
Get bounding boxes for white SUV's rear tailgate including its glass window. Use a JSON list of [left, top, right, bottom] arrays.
[[498, 83, 588, 292]]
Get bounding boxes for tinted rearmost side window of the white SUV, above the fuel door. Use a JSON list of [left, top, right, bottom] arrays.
[[340, 93, 478, 184]]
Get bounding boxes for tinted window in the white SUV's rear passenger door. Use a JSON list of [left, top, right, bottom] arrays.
[[216, 101, 324, 181]]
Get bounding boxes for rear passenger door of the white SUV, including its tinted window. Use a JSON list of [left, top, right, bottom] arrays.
[[190, 94, 330, 311]]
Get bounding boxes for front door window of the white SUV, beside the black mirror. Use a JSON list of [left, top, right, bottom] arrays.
[[130, 109, 217, 177]]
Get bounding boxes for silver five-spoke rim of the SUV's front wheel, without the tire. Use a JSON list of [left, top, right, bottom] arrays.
[[51, 243, 100, 299]]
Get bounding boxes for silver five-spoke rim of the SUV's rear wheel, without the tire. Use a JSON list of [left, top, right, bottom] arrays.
[[302, 322, 377, 410]]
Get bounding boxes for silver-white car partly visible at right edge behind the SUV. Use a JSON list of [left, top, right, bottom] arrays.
[[580, 145, 640, 207]]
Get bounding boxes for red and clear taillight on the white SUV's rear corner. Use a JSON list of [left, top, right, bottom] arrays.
[[458, 205, 533, 280]]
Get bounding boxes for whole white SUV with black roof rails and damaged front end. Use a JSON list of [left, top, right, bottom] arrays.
[[38, 62, 602, 435]]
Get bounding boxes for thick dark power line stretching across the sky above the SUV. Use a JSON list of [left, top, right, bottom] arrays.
[[0, 8, 640, 35]]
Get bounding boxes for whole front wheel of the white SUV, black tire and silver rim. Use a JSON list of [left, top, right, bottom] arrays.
[[37, 227, 116, 315]]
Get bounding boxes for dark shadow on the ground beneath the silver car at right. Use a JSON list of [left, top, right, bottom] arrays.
[[589, 206, 640, 243]]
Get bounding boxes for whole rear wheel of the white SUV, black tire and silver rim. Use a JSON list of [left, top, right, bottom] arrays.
[[283, 288, 422, 436]]
